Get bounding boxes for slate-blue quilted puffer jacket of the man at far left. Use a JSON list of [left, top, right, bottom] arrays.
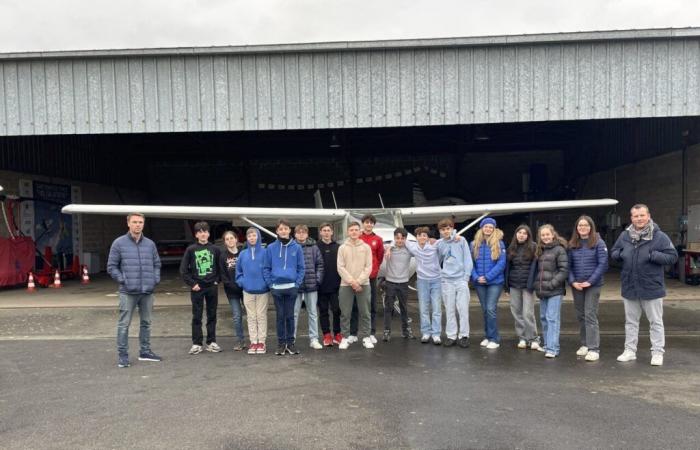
[[107, 233, 160, 294]]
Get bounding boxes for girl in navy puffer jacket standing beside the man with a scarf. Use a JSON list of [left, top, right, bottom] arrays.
[[569, 216, 608, 361]]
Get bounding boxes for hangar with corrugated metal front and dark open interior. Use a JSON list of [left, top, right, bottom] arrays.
[[0, 28, 700, 269]]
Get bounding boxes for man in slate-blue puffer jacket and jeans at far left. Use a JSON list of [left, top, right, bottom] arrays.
[[107, 213, 161, 367]]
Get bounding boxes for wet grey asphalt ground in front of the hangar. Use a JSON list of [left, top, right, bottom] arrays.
[[0, 268, 700, 449]]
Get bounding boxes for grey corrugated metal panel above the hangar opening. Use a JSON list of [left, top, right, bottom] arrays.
[[0, 28, 700, 135]]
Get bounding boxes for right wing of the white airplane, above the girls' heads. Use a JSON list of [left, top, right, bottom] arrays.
[[398, 198, 617, 225]]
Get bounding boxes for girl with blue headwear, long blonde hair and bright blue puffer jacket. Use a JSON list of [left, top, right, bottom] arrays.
[[471, 217, 506, 349]]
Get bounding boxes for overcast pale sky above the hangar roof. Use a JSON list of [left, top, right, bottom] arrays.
[[0, 0, 700, 52]]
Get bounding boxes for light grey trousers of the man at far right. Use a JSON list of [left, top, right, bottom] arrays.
[[622, 298, 665, 354]]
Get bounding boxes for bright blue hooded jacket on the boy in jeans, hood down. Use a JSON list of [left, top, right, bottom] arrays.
[[263, 239, 304, 289]]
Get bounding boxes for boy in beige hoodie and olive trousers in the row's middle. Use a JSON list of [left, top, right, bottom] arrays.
[[338, 222, 374, 350]]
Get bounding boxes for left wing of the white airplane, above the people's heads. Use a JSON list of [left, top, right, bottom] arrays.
[[61, 204, 347, 226]]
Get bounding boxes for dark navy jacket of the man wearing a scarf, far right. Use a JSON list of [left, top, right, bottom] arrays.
[[610, 224, 678, 300]]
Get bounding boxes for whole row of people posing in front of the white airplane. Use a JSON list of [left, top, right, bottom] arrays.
[[108, 204, 677, 367]]
